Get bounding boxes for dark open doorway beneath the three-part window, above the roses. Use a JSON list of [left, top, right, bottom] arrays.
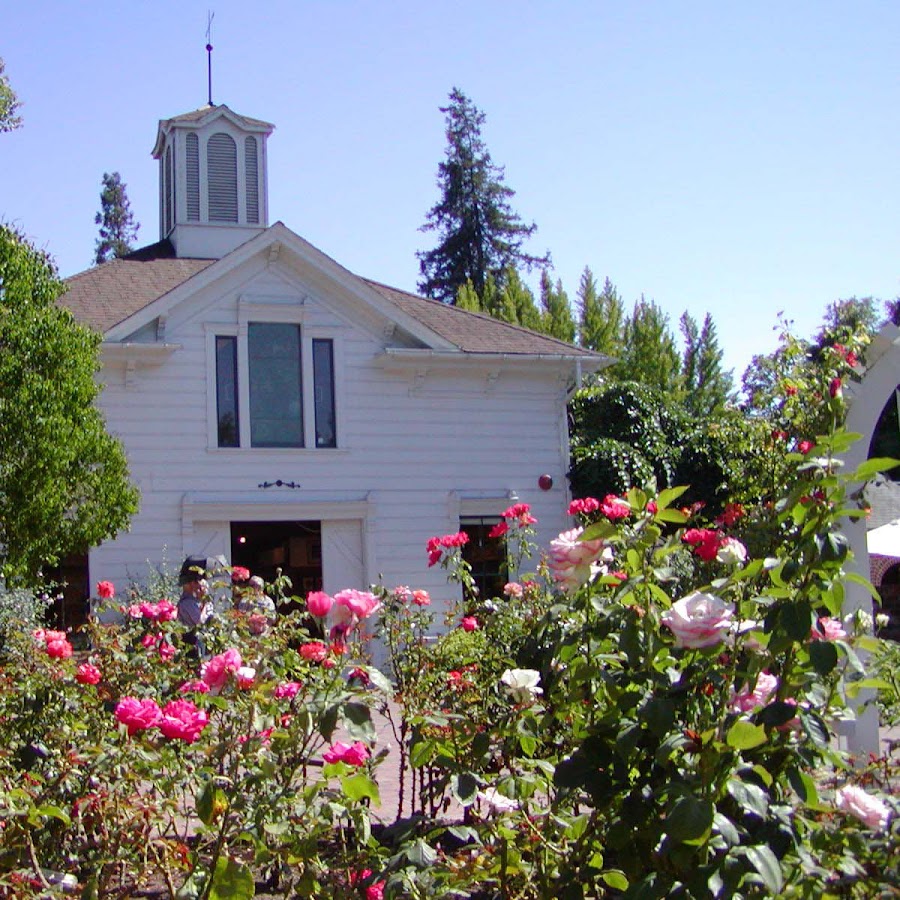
[[231, 521, 322, 599]]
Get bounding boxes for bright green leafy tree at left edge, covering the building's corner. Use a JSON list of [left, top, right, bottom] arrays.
[[0, 225, 138, 580]]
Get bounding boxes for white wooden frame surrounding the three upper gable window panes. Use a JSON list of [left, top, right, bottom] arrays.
[[205, 297, 345, 453]]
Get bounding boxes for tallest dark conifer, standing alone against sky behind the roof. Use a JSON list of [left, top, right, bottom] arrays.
[[416, 88, 549, 303]]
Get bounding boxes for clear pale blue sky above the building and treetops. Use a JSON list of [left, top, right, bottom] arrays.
[[0, 0, 900, 375]]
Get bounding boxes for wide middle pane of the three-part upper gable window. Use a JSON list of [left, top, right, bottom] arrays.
[[247, 322, 303, 447]]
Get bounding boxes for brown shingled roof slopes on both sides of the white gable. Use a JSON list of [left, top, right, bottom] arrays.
[[60, 240, 597, 359]]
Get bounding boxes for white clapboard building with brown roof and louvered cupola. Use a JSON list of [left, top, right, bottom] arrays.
[[63, 105, 604, 612]]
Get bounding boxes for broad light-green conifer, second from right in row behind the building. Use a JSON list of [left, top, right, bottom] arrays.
[[606, 295, 682, 397]]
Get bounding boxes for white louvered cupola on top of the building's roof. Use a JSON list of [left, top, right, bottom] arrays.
[[153, 104, 275, 259]]
